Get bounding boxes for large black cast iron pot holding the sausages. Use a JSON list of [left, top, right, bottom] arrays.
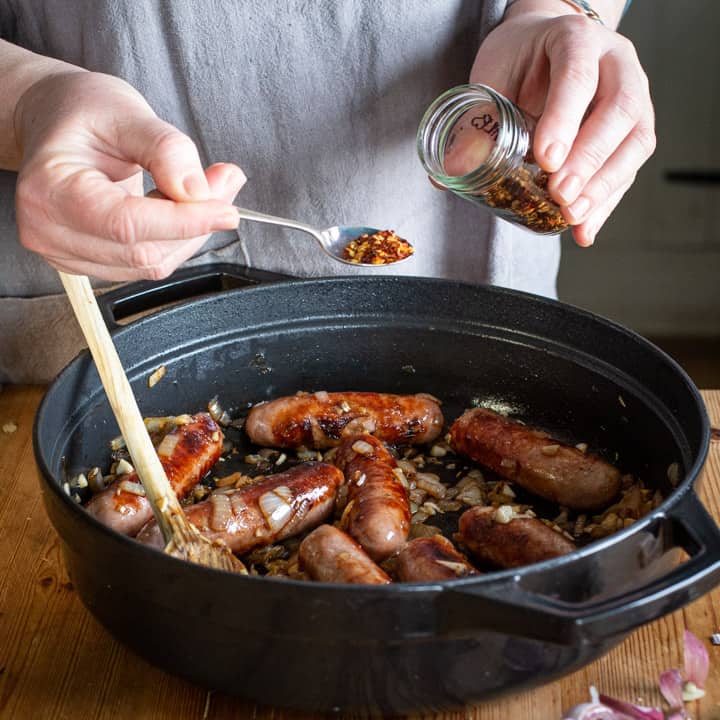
[[34, 266, 720, 713]]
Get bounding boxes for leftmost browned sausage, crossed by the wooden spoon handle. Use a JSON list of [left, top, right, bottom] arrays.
[[86, 413, 223, 536]]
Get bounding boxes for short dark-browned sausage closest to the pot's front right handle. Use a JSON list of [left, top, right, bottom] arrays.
[[456, 507, 575, 568]]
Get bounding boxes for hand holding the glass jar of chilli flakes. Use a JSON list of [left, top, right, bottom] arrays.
[[470, 0, 655, 246]]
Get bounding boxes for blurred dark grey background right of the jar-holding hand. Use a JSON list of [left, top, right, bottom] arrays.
[[558, 0, 720, 388]]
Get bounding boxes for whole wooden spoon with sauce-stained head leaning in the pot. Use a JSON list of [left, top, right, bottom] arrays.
[[59, 272, 247, 573]]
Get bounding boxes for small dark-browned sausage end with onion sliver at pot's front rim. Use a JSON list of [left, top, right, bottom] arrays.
[[396, 535, 478, 582]]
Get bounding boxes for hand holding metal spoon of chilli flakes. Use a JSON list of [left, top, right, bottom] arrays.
[[15, 72, 245, 281]]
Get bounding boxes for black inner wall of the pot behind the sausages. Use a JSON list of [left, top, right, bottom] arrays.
[[39, 278, 702, 512]]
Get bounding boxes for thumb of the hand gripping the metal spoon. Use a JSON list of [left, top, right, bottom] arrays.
[[115, 115, 211, 202]]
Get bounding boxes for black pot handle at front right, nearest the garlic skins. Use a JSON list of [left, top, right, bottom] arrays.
[[442, 491, 720, 645]]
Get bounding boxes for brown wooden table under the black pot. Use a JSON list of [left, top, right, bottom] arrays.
[[0, 387, 720, 720]]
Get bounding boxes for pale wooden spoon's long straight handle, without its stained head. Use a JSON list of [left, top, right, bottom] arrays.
[[59, 272, 182, 540]]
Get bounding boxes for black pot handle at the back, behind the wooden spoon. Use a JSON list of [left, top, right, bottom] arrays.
[[97, 263, 291, 330]]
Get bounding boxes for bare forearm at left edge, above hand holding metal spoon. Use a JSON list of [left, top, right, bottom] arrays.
[[0, 40, 82, 170]]
